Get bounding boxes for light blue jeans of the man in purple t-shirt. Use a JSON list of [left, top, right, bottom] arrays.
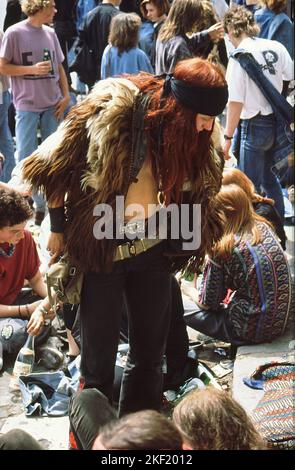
[[15, 106, 58, 212]]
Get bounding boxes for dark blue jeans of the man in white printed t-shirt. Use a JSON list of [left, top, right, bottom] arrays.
[[239, 114, 284, 220]]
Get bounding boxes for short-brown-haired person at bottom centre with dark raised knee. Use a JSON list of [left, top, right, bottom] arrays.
[[69, 388, 182, 450]]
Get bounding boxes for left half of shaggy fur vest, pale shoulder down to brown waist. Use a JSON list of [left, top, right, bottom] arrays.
[[24, 78, 139, 271]]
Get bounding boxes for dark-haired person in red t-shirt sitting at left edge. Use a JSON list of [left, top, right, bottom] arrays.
[[0, 189, 52, 366]]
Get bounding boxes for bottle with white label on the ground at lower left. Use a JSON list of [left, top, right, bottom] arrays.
[[9, 335, 35, 391]]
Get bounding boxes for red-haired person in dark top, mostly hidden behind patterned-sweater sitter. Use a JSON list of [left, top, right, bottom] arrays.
[[222, 168, 287, 250]]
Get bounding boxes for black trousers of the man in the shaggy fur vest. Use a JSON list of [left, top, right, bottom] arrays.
[[80, 241, 171, 415]]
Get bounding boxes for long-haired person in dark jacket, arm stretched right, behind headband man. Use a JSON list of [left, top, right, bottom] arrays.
[[155, 0, 223, 75]]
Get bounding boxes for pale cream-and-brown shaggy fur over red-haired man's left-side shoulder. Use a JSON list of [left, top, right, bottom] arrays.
[[24, 78, 139, 202]]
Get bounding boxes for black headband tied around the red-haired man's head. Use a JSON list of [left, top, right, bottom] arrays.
[[161, 74, 228, 116]]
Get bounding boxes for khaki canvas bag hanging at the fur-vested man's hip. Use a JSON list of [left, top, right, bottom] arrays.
[[46, 253, 83, 311]]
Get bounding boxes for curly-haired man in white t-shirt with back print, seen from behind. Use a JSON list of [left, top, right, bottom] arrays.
[[223, 5, 294, 221]]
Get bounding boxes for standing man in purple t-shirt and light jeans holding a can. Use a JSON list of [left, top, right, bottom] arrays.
[[0, 0, 70, 222]]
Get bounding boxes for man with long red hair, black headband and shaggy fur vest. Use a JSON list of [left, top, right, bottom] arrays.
[[24, 59, 227, 415]]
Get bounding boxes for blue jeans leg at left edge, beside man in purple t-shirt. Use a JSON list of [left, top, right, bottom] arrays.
[[0, 91, 15, 183]]
